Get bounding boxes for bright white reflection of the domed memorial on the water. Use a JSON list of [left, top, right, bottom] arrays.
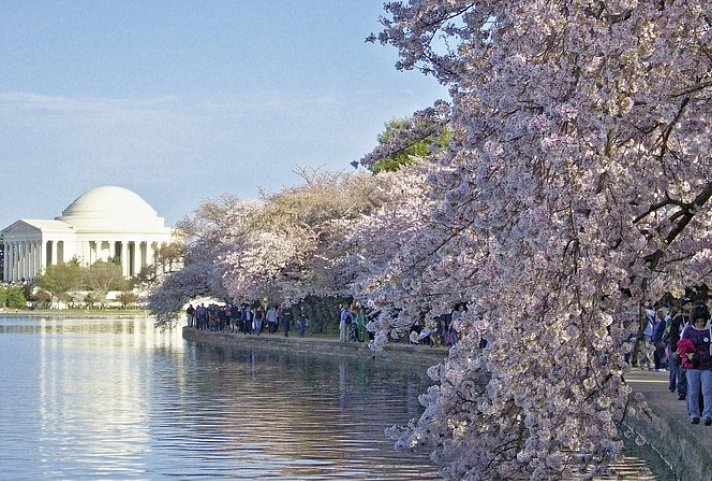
[[35, 318, 182, 479]]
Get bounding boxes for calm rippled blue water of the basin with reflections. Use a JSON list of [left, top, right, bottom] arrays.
[[0, 316, 658, 481]]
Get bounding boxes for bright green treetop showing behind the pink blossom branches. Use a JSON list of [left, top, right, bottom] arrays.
[[371, 118, 450, 174]]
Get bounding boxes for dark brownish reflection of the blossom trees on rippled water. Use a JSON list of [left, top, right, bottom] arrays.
[[177, 345, 438, 480]]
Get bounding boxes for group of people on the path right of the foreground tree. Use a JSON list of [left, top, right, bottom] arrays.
[[644, 298, 712, 426]]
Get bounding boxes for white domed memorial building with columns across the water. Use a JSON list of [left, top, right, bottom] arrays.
[[0, 186, 172, 282]]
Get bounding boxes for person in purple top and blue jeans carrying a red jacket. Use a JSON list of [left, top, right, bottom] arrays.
[[677, 304, 712, 426]]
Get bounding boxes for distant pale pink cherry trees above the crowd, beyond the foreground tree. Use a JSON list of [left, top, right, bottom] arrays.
[[149, 170, 412, 324]]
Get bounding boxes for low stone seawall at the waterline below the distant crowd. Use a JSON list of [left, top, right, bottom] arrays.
[[183, 327, 447, 369]]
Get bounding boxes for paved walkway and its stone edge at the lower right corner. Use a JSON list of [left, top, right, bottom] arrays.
[[626, 370, 712, 481]]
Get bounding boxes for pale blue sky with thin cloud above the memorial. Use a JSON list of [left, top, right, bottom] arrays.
[[0, 0, 446, 228]]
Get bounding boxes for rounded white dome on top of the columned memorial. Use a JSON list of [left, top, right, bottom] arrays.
[[56, 185, 165, 231]]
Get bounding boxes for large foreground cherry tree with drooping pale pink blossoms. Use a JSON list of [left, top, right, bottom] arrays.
[[358, 0, 712, 480]]
